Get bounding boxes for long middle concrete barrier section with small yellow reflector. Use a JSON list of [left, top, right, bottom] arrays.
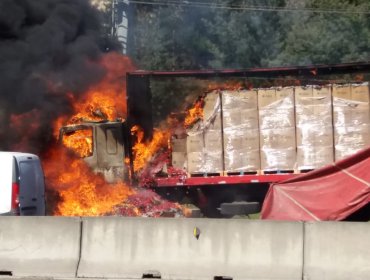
[[77, 217, 303, 280]]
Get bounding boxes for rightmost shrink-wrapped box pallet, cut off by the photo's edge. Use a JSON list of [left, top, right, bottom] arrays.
[[333, 83, 370, 160]]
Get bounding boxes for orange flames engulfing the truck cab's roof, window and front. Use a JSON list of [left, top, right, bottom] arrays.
[[44, 53, 134, 216]]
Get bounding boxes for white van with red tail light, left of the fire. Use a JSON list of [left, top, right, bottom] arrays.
[[0, 152, 45, 216]]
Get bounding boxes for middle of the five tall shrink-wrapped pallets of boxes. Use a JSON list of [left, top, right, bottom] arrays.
[[258, 87, 296, 172]]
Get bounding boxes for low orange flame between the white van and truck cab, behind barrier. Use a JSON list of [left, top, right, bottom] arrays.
[[44, 148, 133, 216]]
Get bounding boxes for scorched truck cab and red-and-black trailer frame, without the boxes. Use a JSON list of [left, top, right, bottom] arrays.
[[60, 63, 370, 217]]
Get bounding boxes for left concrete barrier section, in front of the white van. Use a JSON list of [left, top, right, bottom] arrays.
[[0, 217, 81, 277]]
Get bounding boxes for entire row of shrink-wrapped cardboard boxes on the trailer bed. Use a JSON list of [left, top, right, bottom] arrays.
[[172, 83, 370, 174]]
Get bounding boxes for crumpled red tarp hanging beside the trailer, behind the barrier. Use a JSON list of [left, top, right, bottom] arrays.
[[261, 148, 370, 221]]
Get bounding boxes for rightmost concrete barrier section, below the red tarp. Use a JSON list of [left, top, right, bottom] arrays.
[[304, 222, 370, 280]]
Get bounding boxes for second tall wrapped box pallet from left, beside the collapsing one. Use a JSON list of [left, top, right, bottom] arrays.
[[222, 90, 260, 173]]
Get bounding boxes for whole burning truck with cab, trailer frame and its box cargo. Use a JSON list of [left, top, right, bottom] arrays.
[[59, 64, 370, 217]]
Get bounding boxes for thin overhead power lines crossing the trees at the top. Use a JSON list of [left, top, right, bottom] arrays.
[[130, 0, 370, 15]]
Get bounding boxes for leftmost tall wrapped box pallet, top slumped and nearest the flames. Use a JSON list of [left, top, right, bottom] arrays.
[[186, 91, 223, 173]]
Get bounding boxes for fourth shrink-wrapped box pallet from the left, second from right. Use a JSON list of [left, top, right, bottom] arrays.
[[295, 86, 334, 170]]
